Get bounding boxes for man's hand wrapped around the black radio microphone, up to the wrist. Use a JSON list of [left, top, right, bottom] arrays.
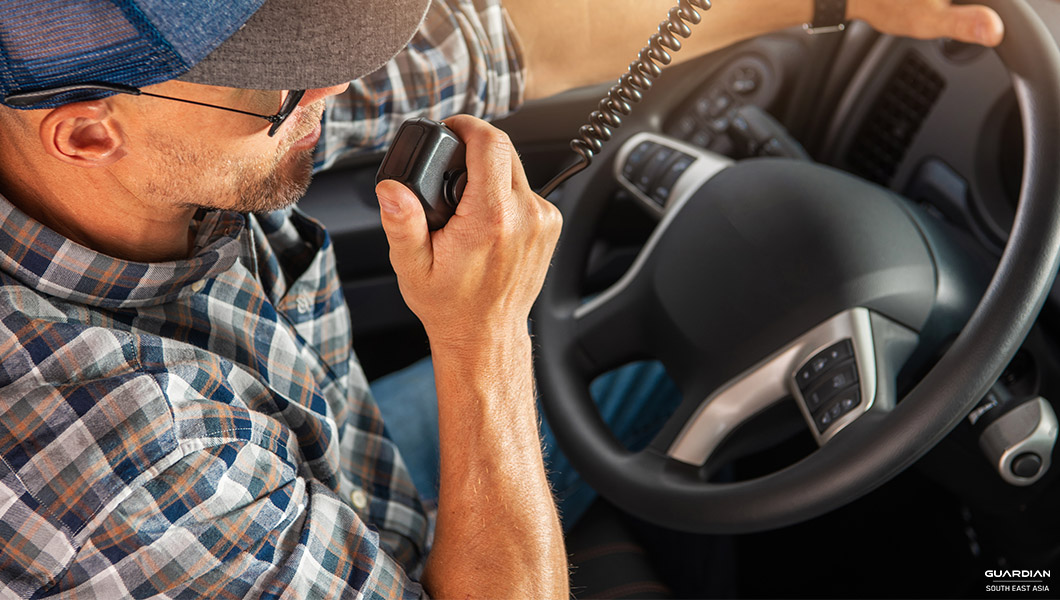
[[376, 117, 562, 346]]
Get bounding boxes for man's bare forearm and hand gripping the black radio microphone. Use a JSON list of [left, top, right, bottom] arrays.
[[376, 117, 569, 598]]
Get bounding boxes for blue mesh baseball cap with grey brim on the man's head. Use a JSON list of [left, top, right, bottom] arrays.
[[0, 0, 429, 108]]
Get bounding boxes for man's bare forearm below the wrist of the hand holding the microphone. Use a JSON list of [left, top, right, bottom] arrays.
[[424, 330, 568, 598]]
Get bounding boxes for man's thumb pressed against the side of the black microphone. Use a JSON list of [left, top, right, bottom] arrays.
[[375, 179, 434, 275]]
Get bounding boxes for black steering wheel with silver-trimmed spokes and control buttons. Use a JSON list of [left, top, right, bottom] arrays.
[[533, 0, 1060, 533]]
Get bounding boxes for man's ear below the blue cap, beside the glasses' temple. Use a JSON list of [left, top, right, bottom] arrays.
[[39, 100, 125, 167]]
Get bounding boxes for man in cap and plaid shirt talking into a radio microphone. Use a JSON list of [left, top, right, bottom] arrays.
[[0, 0, 1001, 598]]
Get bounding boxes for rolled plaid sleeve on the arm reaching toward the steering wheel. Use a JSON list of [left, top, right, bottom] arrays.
[[315, 0, 526, 171]]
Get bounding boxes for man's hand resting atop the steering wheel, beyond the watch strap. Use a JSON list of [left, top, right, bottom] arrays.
[[847, 0, 1005, 46]]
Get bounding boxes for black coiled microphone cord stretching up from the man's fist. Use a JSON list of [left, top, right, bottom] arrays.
[[538, 0, 710, 198]]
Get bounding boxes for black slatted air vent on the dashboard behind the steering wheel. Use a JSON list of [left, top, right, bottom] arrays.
[[847, 52, 946, 186]]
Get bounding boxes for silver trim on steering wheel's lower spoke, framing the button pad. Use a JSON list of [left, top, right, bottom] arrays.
[[667, 307, 877, 466]]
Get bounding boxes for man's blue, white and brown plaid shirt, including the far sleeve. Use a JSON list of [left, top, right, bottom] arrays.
[[0, 0, 524, 598]]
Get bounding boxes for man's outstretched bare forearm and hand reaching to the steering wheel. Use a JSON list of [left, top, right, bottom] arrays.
[[504, 0, 1003, 99]]
